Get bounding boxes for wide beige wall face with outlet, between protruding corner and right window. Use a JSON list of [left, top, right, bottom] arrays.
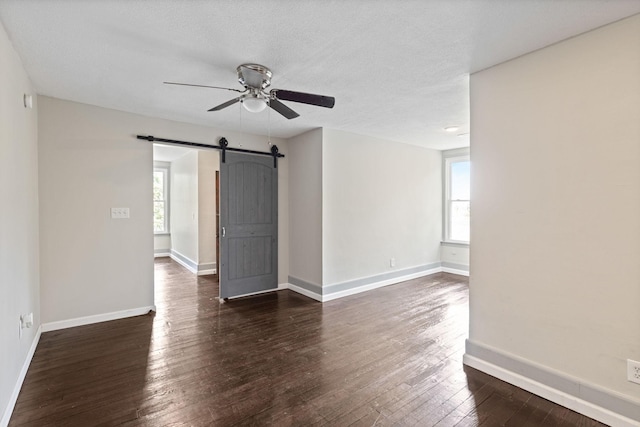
[[322, 129, 442, 286]]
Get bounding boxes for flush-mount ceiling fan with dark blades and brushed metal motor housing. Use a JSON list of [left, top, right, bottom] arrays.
[[164, 64, 336, 119]]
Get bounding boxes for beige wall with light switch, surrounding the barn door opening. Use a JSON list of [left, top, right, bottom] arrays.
[[39, 97, 289, 322]]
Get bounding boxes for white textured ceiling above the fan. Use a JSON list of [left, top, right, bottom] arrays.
[[0, 0, 640, 149]]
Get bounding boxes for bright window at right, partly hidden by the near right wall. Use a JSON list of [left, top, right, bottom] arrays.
[[444, 150, 471, 243]]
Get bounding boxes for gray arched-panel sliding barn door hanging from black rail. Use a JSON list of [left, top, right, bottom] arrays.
[[219, 152, 278, 298]]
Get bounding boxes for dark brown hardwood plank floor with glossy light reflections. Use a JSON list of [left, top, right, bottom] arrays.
[[10, 258, 602, 426]]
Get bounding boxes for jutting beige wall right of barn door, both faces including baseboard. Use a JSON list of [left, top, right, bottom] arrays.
[[289, 129, 442, 301]]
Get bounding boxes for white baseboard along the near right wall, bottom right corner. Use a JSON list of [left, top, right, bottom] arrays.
[[463, 344, 640, 427]]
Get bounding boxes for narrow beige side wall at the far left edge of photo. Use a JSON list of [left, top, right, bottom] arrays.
[[0, 18, 40, 425]]
